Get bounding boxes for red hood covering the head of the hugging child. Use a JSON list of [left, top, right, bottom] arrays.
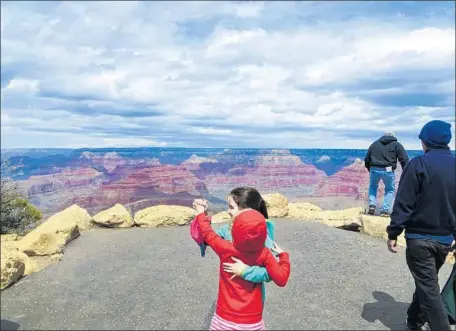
[[232, 209, 267, 252]]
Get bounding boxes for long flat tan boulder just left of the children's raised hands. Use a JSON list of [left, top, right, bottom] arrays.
[[134, 205, 195, 228]]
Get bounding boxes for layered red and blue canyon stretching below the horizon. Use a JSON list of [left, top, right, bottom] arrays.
[[2, 148, 420, 217]]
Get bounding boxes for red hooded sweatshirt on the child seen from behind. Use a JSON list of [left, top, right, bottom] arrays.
[[196, 209, 290, 324]]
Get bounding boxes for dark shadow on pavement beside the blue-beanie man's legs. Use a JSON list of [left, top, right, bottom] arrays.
[[361, 291, 410, 330]]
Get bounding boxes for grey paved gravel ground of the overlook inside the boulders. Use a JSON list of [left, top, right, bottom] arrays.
[[1, 220, 451, 330]]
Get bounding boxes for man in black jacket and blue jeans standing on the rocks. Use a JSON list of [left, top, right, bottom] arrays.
[[364, 132, 409, 216]]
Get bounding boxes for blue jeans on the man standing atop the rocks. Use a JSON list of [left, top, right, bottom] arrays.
[[369, 167, 395, 213]]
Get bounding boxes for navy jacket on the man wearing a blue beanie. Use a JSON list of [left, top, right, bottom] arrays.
[[387, 148, 456, 240]]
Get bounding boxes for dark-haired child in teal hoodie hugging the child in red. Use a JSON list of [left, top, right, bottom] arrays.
[[196, 187, 276, 303]]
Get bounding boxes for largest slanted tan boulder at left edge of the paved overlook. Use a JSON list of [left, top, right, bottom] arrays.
[[18, 206, 84, 256]]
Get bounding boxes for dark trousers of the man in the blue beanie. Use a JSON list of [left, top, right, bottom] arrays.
[[406, 239, 451, 331]]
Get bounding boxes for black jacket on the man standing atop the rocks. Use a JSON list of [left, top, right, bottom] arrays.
[[364, 136, 409, 171]]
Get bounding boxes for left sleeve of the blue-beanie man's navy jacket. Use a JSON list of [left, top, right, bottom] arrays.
[[386, 157, 425, 240]]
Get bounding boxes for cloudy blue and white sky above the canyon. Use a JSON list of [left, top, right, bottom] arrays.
[[1, 1, 455, 149]]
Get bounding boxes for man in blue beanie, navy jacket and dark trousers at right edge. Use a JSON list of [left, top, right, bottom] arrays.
[[387, 121, 456, 330]]
